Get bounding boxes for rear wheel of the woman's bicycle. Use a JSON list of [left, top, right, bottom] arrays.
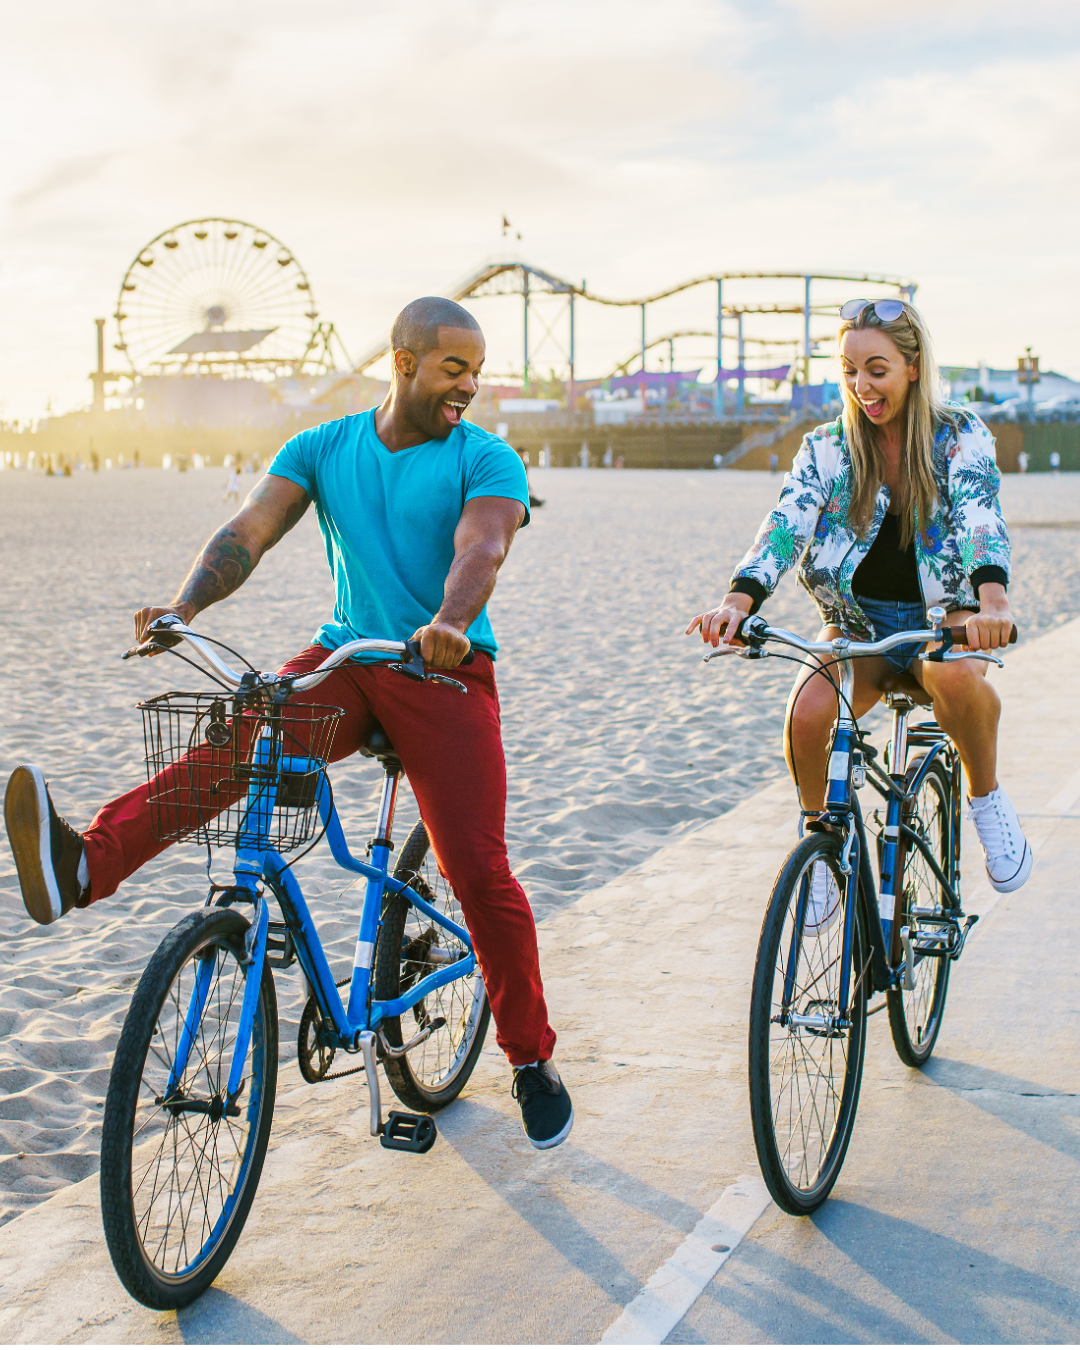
[[886, 761, 952, 1069]]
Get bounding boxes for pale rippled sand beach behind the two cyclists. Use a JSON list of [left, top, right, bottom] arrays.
[[0, 459, 1080, 1222]]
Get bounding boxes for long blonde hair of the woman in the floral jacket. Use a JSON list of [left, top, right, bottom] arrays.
[[837, 300, 956, 548]]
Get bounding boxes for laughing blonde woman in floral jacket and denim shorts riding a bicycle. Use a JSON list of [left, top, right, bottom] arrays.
[[687, 300, 1033, 901]]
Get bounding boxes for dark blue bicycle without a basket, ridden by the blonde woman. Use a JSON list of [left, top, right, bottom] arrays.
[[705, 606, 1017, 1215]]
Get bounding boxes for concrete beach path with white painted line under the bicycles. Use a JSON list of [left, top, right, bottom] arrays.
[[0, 621, 1080, 1343]]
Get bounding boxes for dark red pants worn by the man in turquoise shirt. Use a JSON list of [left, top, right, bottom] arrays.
[[84, 647, 555, 1064]]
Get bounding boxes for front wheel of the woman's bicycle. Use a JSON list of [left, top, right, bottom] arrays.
[[749, 833, 869, 1215]]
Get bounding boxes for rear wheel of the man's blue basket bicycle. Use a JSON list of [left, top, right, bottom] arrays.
[[375, 821, 491, 1111]]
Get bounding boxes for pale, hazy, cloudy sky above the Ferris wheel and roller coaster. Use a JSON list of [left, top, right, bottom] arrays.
[[0, 0, 1080, 421]]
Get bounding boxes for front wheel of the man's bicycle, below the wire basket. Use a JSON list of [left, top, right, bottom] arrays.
[[100, 909, 278, 1310]]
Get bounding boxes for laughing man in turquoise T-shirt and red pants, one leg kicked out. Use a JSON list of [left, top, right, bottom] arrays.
[[4, 296, 574, 1149]]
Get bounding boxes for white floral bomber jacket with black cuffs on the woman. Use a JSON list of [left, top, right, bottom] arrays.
[[732, 404, 1010, 641]]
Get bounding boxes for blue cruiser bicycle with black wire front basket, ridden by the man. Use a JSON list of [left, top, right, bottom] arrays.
[[101, 616, 490, 1308]]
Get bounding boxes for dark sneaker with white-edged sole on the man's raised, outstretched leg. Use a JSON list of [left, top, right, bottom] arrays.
[[4, 764, 90, 923]]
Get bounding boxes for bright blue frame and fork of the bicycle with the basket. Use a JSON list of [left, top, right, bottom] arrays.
[[169, 737, 477, 1107]]
